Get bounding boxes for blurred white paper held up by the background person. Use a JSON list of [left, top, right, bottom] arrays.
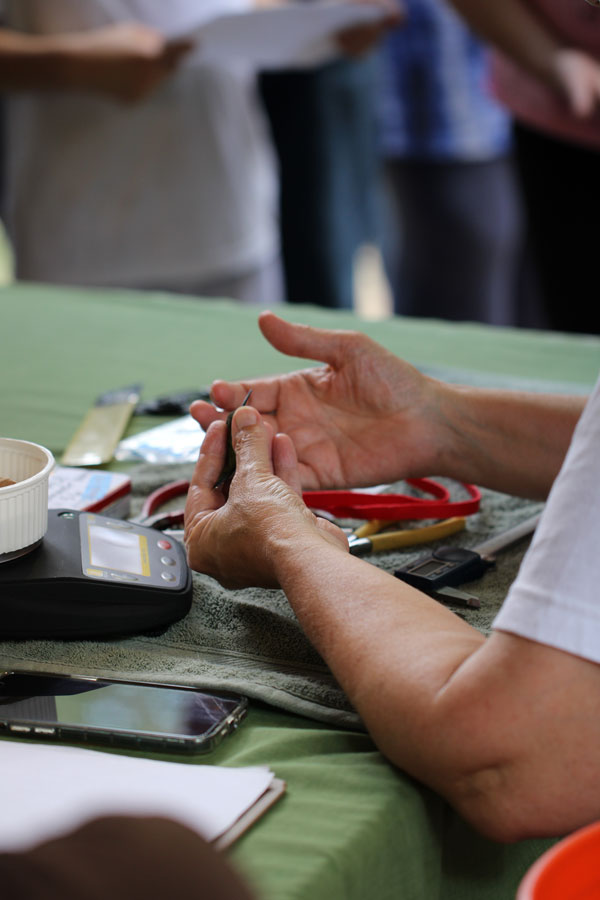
[[178, 0, 385, 69]]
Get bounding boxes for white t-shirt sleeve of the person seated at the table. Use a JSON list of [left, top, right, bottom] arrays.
[[494, 379, 600, 662]]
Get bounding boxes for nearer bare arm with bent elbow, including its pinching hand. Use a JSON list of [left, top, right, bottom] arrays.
[[186, 407, 600, 840]]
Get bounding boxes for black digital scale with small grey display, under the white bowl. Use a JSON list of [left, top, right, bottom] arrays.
[[0, 509, 192, 640]]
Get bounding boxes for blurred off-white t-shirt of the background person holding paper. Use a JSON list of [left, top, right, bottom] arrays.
[[0, 0, 278, 287]]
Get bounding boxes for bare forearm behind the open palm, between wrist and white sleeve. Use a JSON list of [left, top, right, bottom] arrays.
[[435, 387, 585, 499]]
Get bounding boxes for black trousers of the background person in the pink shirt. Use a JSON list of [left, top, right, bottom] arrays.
[[515, 125, 600, 334]]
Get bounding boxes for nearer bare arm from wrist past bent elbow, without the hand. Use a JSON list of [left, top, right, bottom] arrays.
[[276, 541, 600, 841]]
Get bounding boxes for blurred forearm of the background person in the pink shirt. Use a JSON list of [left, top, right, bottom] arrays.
[[451, 0, 562, 83]]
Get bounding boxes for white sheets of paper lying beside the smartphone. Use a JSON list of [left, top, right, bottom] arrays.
[[0, 741, 274, 851]]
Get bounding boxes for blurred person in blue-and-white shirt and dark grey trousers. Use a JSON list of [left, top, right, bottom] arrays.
[[377, 0, 523, 325]]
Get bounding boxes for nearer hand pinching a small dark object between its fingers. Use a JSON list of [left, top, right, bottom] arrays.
[[185, 406, 348, 588]]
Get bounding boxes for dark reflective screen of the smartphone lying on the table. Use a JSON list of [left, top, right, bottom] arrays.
[[0, 674, 241, 736]]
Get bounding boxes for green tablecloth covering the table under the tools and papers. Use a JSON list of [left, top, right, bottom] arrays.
[[0, 285, 600, 900]]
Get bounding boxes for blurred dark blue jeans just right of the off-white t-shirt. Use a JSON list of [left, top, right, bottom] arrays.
[[260, 58, 377, 308]]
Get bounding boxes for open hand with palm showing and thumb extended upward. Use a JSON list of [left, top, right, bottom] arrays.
[[190, 313, 443, 490]]
